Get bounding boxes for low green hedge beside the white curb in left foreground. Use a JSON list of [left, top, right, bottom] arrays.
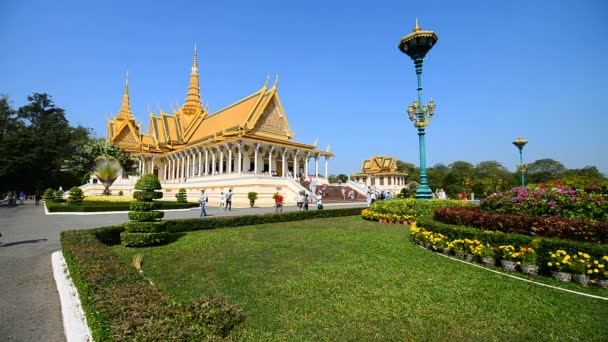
[[61, 227, 244, 341]]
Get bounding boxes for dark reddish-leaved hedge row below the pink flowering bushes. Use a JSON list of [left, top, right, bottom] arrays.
[[435, 208, 608, 243]]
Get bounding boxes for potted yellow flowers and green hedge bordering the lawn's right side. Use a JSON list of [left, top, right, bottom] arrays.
[[410, 220, 608, 286]]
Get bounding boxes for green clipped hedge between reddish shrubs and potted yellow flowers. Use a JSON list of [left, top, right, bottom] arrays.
[[416, 218, 608, 274]]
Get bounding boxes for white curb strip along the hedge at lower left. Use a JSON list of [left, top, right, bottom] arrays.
[[51, 251, 93, 342]]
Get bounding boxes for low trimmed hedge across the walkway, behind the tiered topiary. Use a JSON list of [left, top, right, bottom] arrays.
[[45, 201, 198, 212]]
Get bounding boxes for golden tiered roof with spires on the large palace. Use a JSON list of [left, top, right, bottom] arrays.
[[107, 46, 333, 156]]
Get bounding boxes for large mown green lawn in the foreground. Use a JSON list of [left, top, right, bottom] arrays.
[[115, 217, 608, 340]]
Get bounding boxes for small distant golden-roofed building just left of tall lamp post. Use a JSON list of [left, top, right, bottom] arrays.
[[351, 156, 407, 193]]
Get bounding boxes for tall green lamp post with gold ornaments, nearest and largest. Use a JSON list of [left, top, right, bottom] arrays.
[[399, 19, 439, 200]]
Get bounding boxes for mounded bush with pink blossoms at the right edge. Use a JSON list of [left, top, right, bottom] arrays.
[[480, 184, 608, 221]]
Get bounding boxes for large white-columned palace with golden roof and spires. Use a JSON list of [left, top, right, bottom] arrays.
[[83, 47, 334, 205]]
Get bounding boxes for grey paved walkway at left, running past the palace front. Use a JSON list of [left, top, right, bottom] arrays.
[[0, 201, 362, 341]]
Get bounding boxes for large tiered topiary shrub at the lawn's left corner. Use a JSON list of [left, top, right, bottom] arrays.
[[120, 174, 169, 247]]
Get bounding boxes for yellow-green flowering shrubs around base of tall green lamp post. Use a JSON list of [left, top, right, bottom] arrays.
[[369, 198, 473, 218]]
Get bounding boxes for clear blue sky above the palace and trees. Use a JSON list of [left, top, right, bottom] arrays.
[[0, 0, 608, 174]]
